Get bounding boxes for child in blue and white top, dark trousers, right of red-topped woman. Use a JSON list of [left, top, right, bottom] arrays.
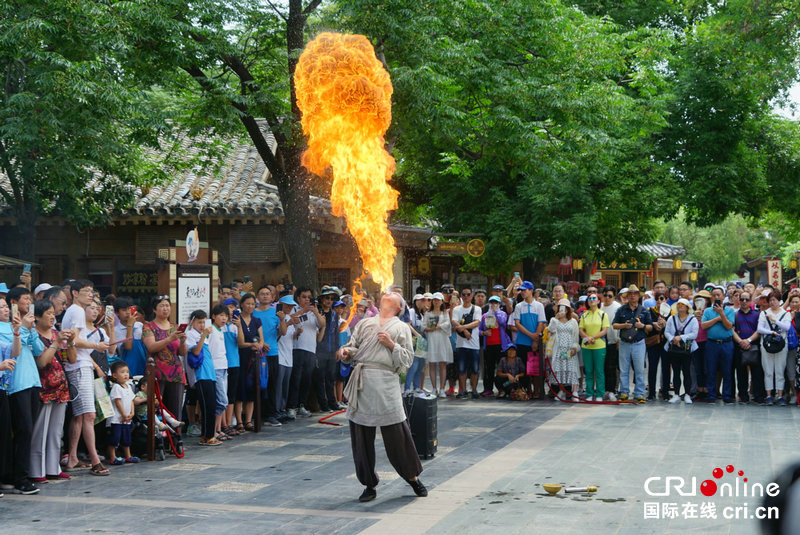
[[186, 310, 222, 446]]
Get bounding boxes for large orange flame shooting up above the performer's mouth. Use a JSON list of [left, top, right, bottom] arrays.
[[294, 33, 398, 292]]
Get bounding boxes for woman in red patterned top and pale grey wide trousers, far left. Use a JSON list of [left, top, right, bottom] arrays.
[[29, 299, 78, 483]]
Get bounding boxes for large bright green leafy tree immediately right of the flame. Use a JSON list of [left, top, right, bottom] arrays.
[[338, 0, 675, 276]]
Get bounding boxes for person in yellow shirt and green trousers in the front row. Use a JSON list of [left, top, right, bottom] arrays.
[[578, 293, 611, 401]]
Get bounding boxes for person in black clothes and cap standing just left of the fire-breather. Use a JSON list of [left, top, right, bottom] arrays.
[[314, 286, 339, 412]]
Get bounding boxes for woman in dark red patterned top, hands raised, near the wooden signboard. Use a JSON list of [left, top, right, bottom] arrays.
[[142, 295, 186, 418]]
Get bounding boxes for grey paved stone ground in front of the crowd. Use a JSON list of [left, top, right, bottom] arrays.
[[0, 399, 800, 535]]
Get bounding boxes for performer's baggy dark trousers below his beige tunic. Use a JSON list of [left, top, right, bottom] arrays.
[[350, 420, 422, 488]]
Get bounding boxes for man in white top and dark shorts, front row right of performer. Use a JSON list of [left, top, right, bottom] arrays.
[[452, 288, 481, 399]]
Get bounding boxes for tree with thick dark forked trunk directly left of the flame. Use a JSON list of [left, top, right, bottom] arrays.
[[117, 0, 324, 287]]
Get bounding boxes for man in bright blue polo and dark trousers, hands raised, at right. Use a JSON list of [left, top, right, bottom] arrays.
[[701, 286, 736, 403]]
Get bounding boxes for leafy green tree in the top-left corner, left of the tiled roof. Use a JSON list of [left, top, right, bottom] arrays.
[[0, 0, 171, 260]]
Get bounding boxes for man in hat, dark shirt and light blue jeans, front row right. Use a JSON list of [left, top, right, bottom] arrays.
[[612, 284, 653, 403]]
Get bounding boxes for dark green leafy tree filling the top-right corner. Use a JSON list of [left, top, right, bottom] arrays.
[[579, 0, 800, 225]]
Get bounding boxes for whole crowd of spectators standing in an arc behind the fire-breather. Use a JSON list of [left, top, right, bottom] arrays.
[[0, 274, 800, 495]]
